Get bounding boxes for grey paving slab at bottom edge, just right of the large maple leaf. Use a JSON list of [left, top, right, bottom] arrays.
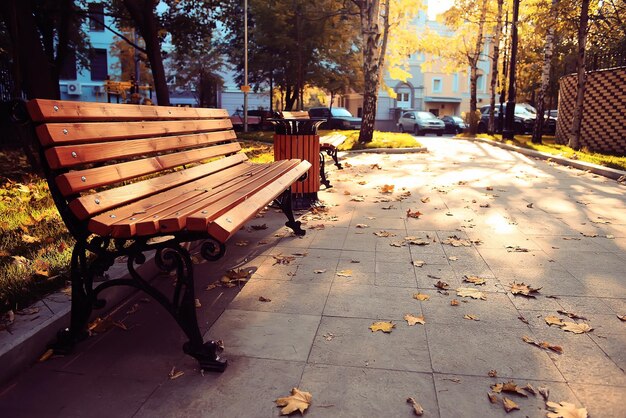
[[301, 364, 439, 417]]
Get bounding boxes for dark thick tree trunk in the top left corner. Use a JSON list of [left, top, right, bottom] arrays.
[[0, 0, 61, 99]]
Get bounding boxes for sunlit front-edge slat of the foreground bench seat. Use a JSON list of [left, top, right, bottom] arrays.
[[206, 161, 311, 242]]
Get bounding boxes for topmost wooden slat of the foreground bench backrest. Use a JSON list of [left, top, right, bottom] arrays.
[[27, 99, 228, 122]]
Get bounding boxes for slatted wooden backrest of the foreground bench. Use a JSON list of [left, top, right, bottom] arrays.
[[27, 99, 247, 233]]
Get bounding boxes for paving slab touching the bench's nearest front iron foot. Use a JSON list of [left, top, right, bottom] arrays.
[[204, 309, 320, 361]]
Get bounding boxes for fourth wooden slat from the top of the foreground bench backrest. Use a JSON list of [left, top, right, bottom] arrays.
[[56, 142, 241, 196]]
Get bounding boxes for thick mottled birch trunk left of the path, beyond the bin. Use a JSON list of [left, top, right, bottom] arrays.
[[359, 0, 384, 143]]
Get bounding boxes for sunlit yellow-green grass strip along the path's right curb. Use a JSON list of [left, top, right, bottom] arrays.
[[464, 134, 626, 170]]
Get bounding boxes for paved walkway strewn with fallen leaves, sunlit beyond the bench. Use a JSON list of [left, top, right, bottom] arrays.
[[0, 137, 626, 417]]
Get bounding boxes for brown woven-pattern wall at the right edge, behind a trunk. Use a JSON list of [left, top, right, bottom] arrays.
[[556, 67, 626, 155]]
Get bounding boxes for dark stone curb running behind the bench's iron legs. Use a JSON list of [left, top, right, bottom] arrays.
[[0, 254, 159, 385]]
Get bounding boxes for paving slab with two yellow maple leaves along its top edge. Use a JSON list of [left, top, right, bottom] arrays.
[[308, 316, 432, 372]]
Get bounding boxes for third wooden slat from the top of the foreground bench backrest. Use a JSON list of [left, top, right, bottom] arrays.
[[46, 131, 237, 169]]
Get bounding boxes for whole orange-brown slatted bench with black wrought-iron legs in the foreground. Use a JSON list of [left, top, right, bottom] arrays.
[[14, 99, 310, 371]]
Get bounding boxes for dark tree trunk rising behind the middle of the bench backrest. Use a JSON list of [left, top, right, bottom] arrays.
[[124, 0, 170, 106]]
